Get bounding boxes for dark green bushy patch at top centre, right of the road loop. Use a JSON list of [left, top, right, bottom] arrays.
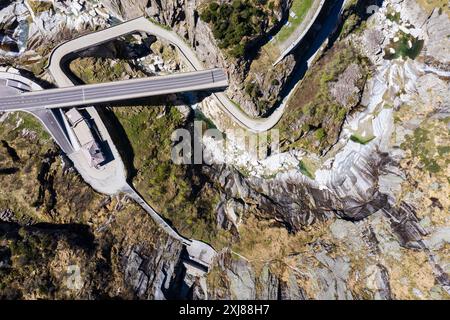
[[200, 0, 268, 58]]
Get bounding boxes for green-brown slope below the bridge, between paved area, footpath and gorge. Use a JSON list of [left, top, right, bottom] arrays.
[[113, 106, 225, 243]]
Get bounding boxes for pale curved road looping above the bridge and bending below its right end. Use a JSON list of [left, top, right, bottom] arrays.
[[48, 17, 284, 132]]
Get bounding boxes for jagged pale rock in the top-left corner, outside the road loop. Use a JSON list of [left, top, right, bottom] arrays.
[[0, 0, 110, 73]]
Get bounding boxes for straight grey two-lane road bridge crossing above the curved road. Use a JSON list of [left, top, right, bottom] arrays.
[[0, 69, 228, 111]]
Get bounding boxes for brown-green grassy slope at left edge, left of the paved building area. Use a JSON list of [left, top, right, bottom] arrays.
[[0, 108, 103, 223]]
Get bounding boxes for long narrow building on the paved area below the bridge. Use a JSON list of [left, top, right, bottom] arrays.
[[65, 108, 106, 168]]
